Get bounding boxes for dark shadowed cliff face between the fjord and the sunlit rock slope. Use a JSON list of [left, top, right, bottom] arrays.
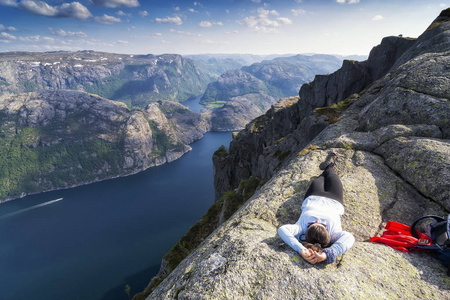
[[215, 28, 426, 199]]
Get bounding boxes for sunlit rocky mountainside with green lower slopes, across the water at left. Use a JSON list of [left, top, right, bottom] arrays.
[[0, 90, 209, 201]]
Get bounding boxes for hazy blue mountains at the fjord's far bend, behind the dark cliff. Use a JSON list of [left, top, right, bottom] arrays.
[[200, 55, 342, 130]]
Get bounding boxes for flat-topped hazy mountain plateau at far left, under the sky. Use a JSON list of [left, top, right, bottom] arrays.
[[0, 51, 213, 108]]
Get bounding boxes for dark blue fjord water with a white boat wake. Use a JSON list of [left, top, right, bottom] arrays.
[[0, 133, 231, 300]]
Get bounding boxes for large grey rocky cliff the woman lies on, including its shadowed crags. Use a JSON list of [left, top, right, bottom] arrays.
[[148, 10, 450, 299]]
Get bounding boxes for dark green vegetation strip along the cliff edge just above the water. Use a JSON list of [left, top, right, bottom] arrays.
[[133, 177, 265, 300]]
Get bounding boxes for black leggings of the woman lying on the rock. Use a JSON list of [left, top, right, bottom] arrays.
[[305, 167, 344, 204]]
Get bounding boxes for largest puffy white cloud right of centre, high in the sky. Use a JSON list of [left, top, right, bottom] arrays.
[[238, 8, 292, 33]]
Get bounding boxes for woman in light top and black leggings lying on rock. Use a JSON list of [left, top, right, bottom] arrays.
[[278, 153, 355, 264]]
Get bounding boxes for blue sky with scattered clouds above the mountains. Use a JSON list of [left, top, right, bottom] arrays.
[[0, 0, 450, 55]]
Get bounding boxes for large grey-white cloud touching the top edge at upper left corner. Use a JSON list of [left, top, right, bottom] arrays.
[[9, 0, 92, 19]]
